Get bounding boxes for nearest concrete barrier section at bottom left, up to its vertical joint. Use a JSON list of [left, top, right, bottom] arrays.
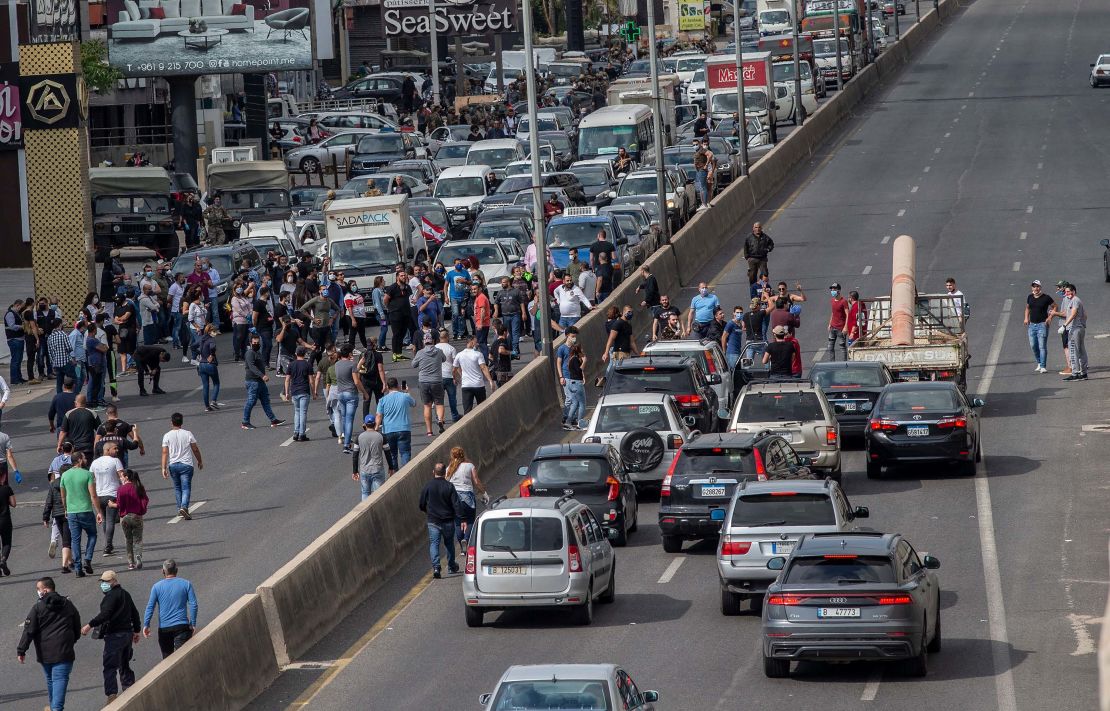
[[105, 595, 279, 711]]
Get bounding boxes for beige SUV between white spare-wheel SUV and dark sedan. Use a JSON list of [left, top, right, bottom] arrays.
[[728, 378, 841, 481]]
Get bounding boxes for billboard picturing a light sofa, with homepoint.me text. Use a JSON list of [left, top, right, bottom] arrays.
[[108, 0, 312, 77]]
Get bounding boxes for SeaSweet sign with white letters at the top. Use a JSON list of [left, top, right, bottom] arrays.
[[382, 0, 519, 37]]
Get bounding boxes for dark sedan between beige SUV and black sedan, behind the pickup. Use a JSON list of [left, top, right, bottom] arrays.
[[809, 360, 895, 436]]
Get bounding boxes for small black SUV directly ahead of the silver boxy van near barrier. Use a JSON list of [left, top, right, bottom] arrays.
[[517, 444, 638, 546]]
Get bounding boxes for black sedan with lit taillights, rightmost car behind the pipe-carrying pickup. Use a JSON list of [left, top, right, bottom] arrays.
[[864, 380, 983, 479]]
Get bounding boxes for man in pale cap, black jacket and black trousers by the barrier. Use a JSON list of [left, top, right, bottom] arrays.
[[81, 570, 141, 703]]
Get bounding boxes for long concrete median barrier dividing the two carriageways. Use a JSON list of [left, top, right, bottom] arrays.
[[107, 0, 963, 711]]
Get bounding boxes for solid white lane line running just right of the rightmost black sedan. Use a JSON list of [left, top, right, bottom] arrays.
[[975, 298, 1018, 711]]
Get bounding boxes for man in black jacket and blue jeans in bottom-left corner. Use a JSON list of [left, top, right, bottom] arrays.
[[16, 578, 81, 711]]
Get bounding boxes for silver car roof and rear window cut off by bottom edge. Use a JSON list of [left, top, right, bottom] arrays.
[[478, 664, 659, 711]]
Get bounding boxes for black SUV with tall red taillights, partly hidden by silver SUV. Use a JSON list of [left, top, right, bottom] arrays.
[[659, 430, 814, 553]]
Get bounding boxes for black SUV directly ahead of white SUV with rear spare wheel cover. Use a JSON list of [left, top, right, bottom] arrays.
[[602, 356, 727, 433]]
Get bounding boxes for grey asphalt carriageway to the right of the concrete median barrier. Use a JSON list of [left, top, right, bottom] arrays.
[[252, 0, 1110, 711]]
